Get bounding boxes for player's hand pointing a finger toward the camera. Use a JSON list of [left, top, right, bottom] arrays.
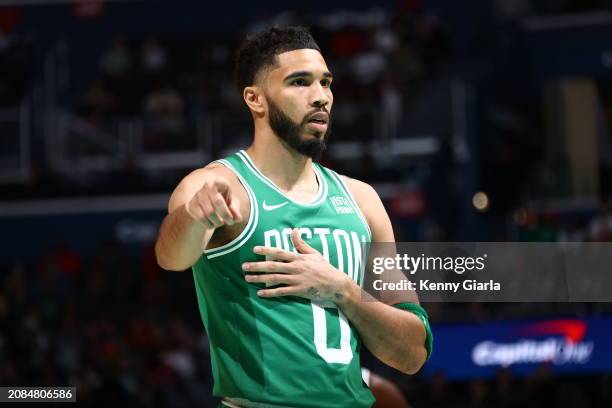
[[185, 176, 242, 229]]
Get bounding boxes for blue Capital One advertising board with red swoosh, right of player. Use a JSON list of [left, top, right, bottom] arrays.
[[423, 317, 612, 380]]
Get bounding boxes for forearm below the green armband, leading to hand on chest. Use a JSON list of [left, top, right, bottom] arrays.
[[336, 281, 427, 374]]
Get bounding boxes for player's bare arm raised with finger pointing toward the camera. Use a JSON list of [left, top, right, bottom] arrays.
[[155, 163, 249, 271]]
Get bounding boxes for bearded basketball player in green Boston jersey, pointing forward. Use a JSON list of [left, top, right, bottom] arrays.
[[155, 27, 431, 408]]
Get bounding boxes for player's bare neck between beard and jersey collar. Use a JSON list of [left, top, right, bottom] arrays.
[[246, 139, 317, 191]]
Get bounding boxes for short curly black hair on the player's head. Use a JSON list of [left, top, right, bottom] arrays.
[[234, 26, 321, 91]]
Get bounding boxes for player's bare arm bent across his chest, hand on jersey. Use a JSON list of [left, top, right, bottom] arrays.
[[243, 179, 427, 374]]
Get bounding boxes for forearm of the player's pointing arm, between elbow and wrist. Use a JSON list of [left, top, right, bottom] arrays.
[[155, 205, 212, 271]]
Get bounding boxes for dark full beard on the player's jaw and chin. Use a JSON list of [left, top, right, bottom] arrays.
[[268, 98, 331, 161]]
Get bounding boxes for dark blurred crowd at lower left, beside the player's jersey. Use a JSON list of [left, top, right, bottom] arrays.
[[0, 243, 214, 407]]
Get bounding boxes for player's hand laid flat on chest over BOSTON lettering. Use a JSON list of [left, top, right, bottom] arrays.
[[242, 228, 349, 301]]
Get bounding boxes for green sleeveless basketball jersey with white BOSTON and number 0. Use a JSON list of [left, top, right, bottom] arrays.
[[193, 151, 374, 408]]
